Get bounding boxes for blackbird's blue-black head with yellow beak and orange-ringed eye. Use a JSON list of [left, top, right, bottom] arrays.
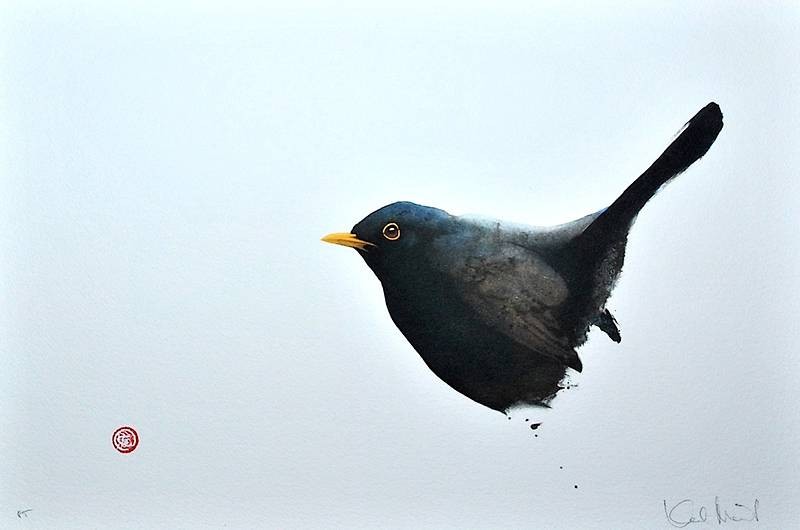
[[322, 202, 453, 281]]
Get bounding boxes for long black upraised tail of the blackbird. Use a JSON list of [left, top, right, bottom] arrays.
[[578, 102, 722, 248]]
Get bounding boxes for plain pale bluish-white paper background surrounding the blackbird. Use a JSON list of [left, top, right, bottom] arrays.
[[0, 2, 800, 529]]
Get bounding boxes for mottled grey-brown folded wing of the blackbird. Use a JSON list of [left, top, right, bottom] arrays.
[[438, 238, 582, 372]]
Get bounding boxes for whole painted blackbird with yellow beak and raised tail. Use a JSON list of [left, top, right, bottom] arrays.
[[322, 102, 722, 412]]
